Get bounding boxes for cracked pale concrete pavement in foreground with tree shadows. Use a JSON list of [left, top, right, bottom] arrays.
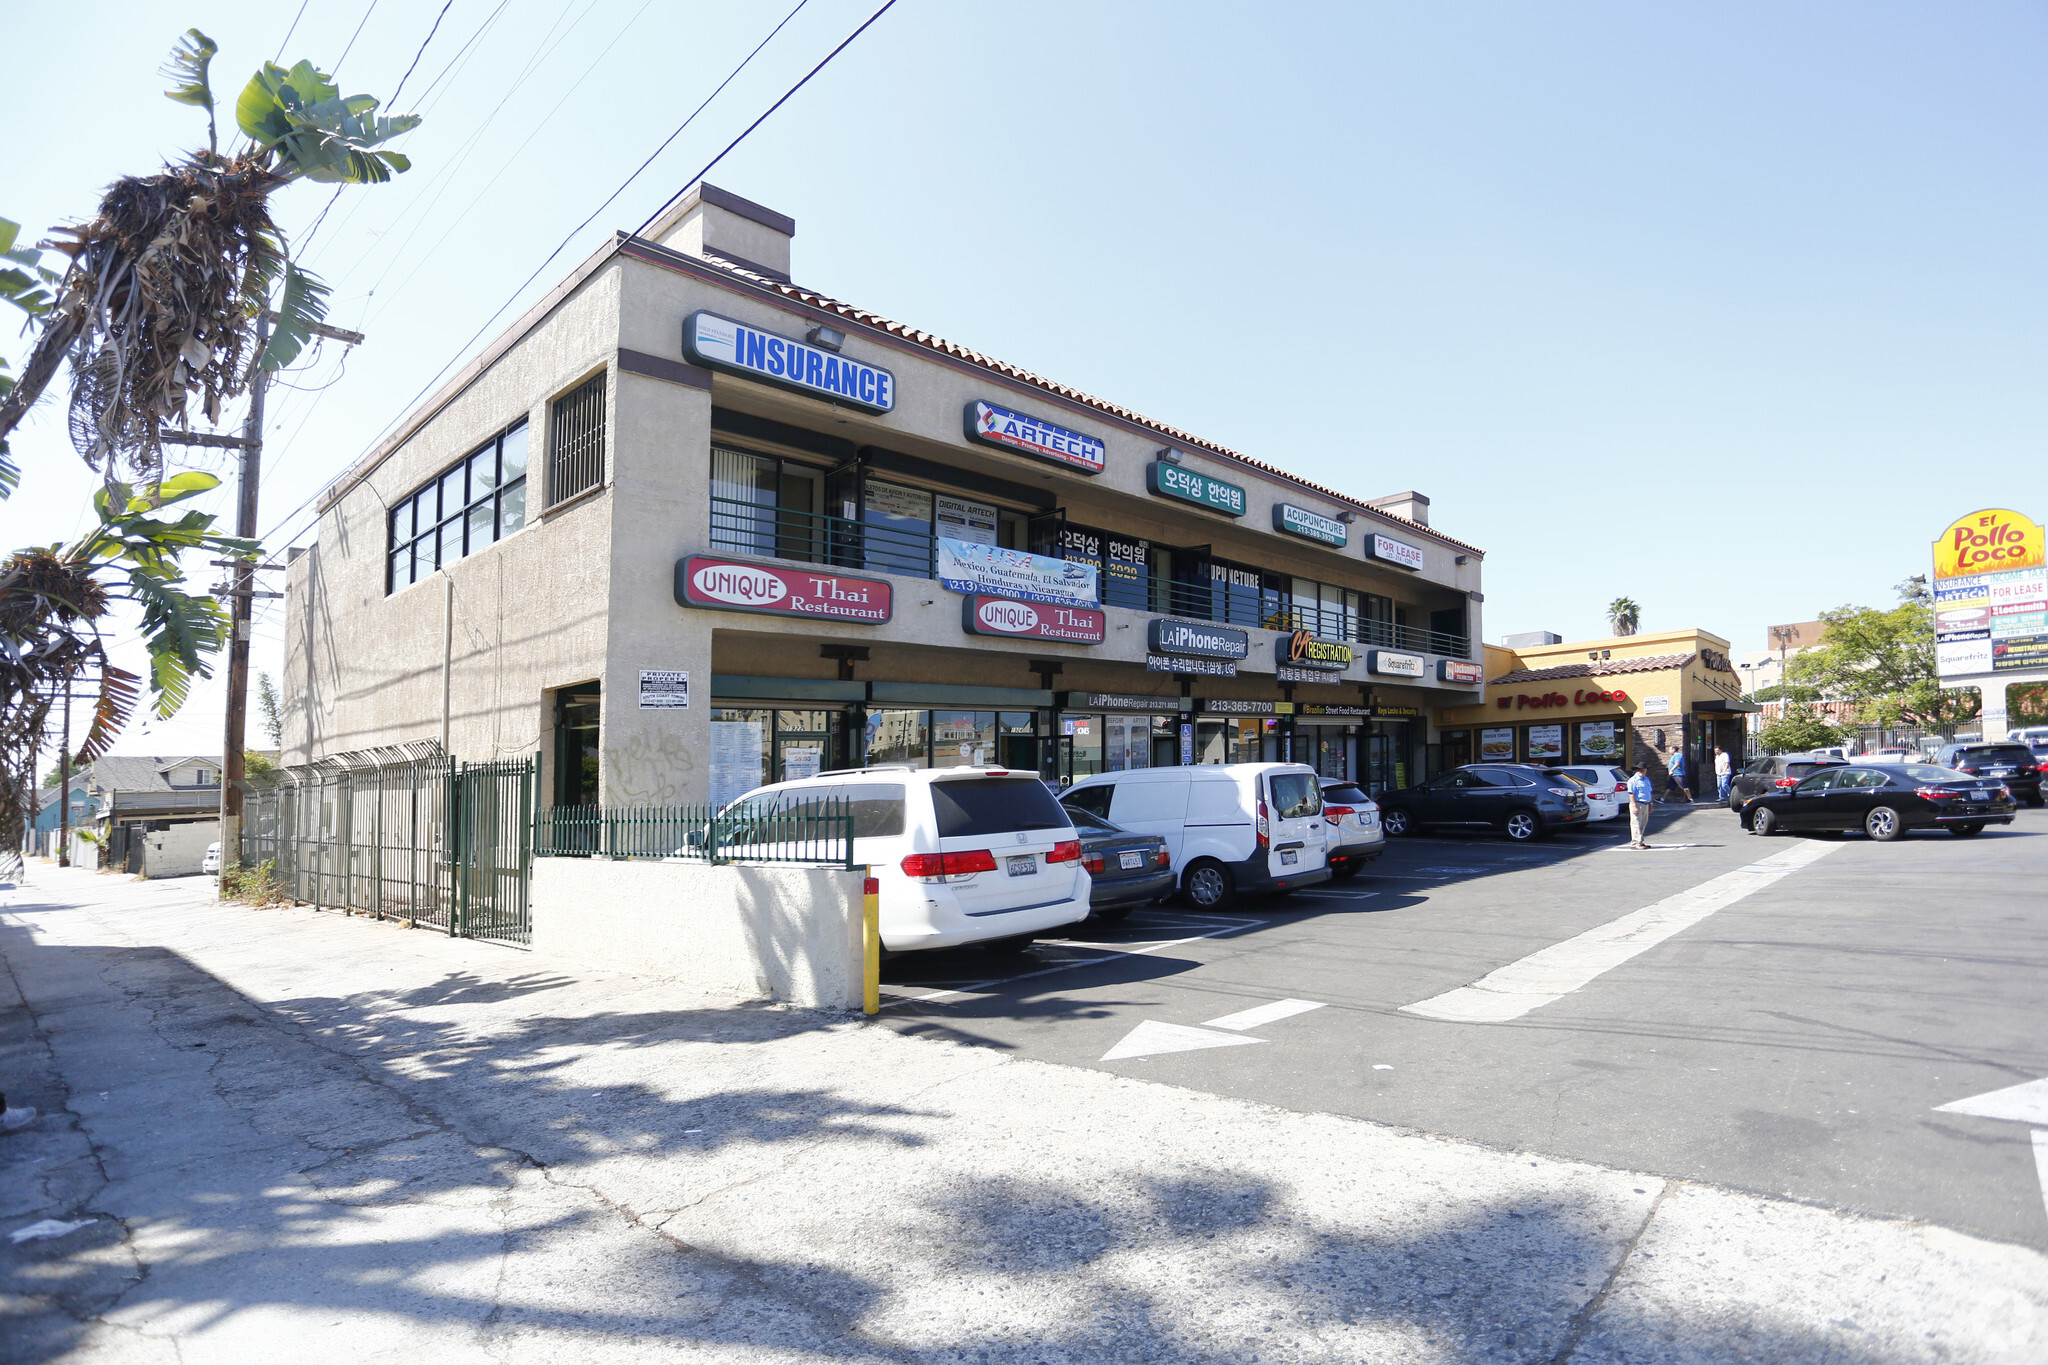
[[0, 864, 2048, 1365]]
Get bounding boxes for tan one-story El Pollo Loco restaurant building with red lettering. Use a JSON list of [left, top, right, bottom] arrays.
[[1436, 630, 1755, 794]]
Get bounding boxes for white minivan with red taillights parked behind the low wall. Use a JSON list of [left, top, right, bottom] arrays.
[[719, 767, 1092, 952]]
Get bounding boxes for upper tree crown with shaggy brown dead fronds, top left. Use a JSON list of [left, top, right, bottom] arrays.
[[0, 29, 420, 479]]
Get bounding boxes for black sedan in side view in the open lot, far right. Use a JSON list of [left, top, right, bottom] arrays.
[[1743, 763, 2017, 843]]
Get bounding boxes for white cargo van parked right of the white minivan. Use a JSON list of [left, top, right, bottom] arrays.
[[1061, 763, 1329, 911]]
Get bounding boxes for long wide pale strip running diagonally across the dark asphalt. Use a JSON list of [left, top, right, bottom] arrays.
[[1401, 843, 1847, 1023]]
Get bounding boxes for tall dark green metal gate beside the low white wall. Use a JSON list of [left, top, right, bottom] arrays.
[[449, 757, 541, 943]]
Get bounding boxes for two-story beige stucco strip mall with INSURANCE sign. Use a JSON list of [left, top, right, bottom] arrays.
[[285, 175, 1483, 804]]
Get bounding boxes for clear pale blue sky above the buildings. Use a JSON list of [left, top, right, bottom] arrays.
[[0, 0, 2048, 753]]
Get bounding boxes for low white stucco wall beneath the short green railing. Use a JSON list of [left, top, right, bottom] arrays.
[[532, 857, 864, 1009]]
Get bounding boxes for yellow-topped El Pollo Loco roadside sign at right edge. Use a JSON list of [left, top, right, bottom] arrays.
[[1933, 508, 2048, 677]]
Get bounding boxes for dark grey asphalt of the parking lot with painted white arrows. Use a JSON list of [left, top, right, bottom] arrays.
[[883, 804, 2048, 1246]]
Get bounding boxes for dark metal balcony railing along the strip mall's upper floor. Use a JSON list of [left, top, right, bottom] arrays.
[[711, 495, 1470, 659]]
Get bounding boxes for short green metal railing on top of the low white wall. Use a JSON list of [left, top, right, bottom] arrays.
[[532, 798, 854, 868]]
